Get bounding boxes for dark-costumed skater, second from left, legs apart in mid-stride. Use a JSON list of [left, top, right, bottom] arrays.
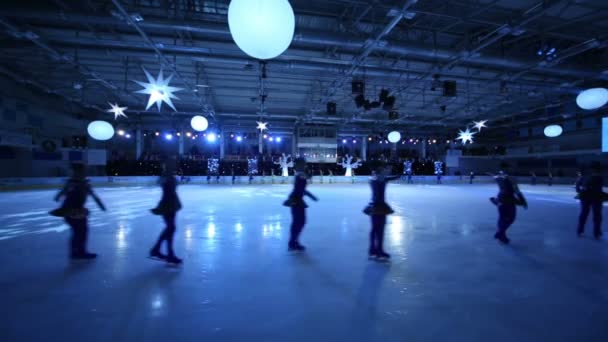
[[150, 162, 182, 264]]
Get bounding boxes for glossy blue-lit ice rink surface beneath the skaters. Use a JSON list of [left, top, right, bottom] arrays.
[[0, 184, 608, 342]]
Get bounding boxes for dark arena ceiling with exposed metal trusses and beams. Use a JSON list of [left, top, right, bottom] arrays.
[[0, 0, 608, 133]]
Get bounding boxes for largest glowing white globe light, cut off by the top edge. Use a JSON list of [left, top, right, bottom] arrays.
[[228, 0, 295, 59]]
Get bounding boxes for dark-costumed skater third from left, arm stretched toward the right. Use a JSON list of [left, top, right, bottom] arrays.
[[283, 158, 318, 251]]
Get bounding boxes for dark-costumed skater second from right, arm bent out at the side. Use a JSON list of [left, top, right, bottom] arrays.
[[490, 165, 528, 244]]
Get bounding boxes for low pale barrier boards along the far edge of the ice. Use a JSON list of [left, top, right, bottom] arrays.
[[0, 176, 575, 191]]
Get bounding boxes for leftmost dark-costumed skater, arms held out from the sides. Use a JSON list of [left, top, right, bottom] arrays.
[[49, 164, 106, 259]]
